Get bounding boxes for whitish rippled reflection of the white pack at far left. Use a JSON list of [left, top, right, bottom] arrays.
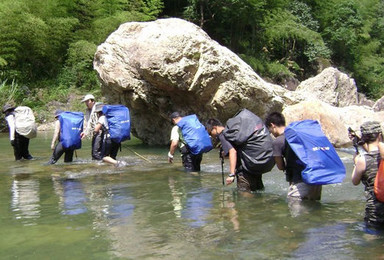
[[11, 175, 40, 221]]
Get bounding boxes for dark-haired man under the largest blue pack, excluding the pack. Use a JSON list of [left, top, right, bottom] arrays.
[[265, 112, 322, 200]]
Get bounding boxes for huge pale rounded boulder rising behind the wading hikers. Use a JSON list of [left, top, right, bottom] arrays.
[[94, 18, 293, 144]]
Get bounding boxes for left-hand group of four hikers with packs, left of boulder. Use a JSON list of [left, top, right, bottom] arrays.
[[3, 94, 130, 166]]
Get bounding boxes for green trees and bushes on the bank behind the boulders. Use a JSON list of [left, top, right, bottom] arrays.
[[0, 0, 384, 128]]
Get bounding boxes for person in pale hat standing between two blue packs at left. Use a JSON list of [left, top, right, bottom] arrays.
[[81, 94, 101, 160]]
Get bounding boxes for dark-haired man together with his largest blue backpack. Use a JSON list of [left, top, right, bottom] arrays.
[[266, 112, 345, 200]]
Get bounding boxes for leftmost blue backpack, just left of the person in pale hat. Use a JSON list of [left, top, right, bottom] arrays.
[[59, 112, 84, 150]]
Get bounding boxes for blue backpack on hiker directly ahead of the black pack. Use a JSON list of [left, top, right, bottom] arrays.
[[177, 115, 212, 155]]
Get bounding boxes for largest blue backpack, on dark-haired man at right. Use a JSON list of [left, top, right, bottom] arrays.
[[284, 120, 345, 185]]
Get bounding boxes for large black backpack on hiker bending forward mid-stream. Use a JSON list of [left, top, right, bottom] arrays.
[[223, 108, 275, 174]]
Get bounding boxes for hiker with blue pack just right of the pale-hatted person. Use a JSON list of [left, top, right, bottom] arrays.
[[94, 104, 131, 166]]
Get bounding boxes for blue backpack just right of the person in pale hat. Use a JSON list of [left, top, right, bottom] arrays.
[[102, 105, 131, 143]]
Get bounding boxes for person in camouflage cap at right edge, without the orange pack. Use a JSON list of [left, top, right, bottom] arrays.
[[352, 121, 384, 230]]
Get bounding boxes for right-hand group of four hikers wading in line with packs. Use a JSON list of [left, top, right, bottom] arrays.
[[168, 109, 384, 230]]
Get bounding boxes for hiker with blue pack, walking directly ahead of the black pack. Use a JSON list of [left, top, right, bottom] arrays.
[[168, 112, 212, 172]]
